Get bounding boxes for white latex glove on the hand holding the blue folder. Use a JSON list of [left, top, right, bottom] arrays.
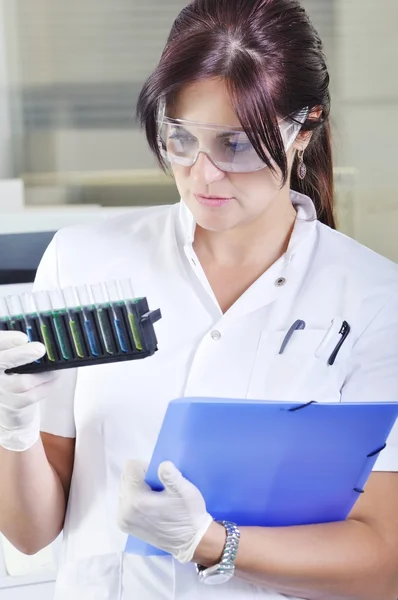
[[118, 460, 213, 563]]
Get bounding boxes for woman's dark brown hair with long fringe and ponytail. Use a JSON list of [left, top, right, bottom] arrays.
[[137, 0, 335, 228]]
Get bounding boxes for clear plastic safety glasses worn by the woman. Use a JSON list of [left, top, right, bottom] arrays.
[[158, 109, 308, 173]]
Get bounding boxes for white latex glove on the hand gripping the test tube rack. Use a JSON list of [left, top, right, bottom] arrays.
[[0, 331, 58, 452]]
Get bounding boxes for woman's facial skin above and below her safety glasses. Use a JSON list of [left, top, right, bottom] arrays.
[[167, 79, 294, 236]]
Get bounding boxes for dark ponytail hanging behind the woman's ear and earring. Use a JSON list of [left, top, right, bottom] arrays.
[[290, 121, 336, 229]]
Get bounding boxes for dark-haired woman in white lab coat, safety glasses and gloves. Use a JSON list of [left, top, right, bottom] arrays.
[[0, 0, 398, 600]]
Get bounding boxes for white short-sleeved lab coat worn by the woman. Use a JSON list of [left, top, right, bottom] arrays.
[[36, 193, 398, 600]]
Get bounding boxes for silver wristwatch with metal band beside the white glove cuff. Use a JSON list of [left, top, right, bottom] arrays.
[[196, 521, 240, 585]]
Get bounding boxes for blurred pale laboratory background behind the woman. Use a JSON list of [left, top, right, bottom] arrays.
[[0, 0, 398, 600]]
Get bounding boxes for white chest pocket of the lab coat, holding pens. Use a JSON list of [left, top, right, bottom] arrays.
[[248, 328, 342, 402]]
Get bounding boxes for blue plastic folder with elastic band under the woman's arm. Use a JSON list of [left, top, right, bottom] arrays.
[[125, 398, 398, 556]]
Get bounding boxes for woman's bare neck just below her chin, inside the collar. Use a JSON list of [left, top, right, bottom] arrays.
[[194, 197, 296, 267]]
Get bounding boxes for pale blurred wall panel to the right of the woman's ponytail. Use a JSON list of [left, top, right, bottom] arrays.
[[335, 0, 398, 261]]
